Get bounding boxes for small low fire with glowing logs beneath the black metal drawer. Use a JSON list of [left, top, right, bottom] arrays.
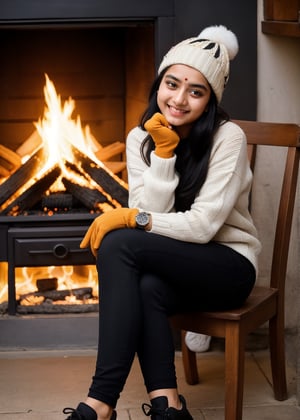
[[0, 263, 99, 314]]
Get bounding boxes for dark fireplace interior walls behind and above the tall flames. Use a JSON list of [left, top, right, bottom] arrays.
[[0, 21, 154, 156]]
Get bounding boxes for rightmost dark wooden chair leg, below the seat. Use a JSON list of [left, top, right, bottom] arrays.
[[269, 316, 288, 401]]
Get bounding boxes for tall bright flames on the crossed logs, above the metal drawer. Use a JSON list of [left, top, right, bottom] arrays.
[[0, 74, 128, 215]]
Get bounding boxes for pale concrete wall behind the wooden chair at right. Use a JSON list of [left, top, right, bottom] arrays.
[[255, 0, 300, 331]]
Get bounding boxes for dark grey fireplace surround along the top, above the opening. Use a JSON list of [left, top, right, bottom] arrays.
[[0, 0, 175, 66]]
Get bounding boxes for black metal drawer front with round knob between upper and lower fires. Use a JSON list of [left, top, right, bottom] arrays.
[[0, 215, 96, 315]]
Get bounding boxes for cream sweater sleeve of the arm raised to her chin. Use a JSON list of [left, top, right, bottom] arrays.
[[126, 127, 179, 213]]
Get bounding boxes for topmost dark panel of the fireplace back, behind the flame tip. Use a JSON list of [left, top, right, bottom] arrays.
[[0, 29, 124, 98]]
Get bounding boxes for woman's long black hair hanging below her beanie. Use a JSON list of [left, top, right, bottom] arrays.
[[140, 68, 229, 211]]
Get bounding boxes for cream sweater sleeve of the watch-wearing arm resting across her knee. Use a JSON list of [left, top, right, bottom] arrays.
[[151, 123, 255, 243]]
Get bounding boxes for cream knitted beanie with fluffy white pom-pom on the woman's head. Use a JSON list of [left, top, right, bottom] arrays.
[[158, 25, 239, 103]]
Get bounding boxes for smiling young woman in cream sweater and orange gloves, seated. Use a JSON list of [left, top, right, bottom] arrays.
[[64, 26, 260, 420]]
